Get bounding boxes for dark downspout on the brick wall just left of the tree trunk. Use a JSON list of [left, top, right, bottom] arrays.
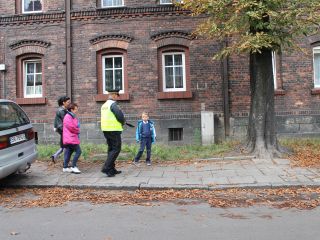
[[221, 40, 230, 137]]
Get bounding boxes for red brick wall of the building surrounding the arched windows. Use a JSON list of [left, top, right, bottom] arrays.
[[0, 0, 320, 129]]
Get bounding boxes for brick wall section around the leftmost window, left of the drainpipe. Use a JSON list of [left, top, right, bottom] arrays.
[[4, 23, 66, 121]]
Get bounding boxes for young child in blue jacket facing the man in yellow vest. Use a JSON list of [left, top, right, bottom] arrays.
[[133, 112, 156, 166]]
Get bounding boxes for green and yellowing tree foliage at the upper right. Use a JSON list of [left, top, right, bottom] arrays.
[[181, 0, 320, 57]]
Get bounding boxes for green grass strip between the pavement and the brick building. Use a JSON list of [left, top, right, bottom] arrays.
[[38, 141, 235, 161]]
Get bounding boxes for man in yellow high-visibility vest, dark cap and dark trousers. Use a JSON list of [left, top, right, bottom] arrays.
[[101, 89, 126, 177]]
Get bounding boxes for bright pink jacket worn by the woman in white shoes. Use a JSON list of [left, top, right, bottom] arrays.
[[63, 112, 80, 144]]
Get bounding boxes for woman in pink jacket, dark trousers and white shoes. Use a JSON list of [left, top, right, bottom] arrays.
[[62, 103, 81, 173]]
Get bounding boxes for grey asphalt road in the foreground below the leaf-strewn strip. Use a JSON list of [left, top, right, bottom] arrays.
[[0, 202, 320, 240]]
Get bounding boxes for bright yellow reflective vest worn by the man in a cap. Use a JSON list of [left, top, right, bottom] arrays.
[[101, 99, 123, 131]]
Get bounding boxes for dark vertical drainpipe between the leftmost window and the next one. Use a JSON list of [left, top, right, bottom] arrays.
[[65, 0, 72, 98]]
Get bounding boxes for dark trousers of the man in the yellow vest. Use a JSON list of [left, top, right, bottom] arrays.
[[102, 131, 121, 173]]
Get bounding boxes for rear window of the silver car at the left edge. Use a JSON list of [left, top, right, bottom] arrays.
[[0, 102, 30, 131]]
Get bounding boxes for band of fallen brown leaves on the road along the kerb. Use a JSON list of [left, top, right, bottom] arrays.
[[0, 187, 320, 209]]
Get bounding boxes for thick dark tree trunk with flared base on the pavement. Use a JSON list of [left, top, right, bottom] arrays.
[[246, 49, 282, 159]]
